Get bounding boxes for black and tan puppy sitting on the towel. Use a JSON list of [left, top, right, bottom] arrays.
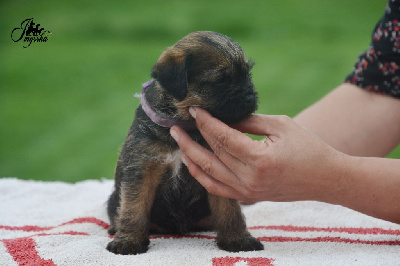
[[107, 32, 264, 255]]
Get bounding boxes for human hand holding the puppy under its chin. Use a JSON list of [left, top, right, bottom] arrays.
[[171, 108, 344, 202]]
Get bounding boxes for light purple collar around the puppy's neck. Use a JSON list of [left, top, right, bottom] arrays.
[[135, 80, 197, 130]]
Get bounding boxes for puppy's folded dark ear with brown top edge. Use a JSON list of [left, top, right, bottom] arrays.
[[151, 48, 190, 101]]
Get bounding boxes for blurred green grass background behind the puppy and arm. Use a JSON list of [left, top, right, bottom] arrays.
[[0, 0, 400, 182]]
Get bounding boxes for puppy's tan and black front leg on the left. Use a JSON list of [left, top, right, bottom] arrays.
[[107, 163, 165, 255]]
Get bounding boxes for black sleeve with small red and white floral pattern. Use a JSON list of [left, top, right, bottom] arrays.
[[345, 0, 400, 98]]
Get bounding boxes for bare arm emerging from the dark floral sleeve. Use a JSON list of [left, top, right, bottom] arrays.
[[294, 83, 400, 157]]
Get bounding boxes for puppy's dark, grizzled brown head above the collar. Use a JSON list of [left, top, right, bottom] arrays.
[[151, 31, 257, 123]]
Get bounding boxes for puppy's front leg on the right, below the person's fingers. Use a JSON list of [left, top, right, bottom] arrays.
[[208, 194, 264, 252]]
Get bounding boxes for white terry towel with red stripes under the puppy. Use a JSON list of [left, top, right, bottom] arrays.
[[0, 178, 400, 266]]
